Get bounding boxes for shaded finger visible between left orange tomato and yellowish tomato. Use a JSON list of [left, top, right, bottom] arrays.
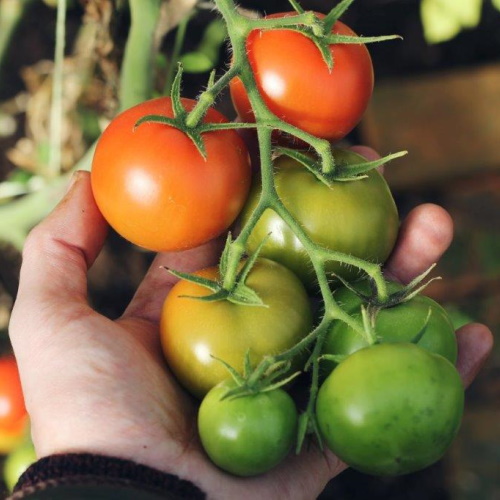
[[122, 238, 224, 322]]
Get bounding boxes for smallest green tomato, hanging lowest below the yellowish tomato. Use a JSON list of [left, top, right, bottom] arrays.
[[198, 380, 298, 476]]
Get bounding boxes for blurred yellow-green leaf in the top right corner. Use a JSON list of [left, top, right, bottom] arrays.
[[420, 0, 482, 44]]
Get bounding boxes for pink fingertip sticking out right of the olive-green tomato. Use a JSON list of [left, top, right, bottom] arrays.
[[385, 203, 453, 283]]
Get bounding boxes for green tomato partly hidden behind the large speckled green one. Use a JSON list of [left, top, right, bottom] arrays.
[[322, 281, 457, 372]]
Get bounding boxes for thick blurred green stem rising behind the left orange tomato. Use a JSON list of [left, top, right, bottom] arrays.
[[119, 0, 161, 111]]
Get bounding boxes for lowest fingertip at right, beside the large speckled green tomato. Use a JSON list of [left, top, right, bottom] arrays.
[[457, 323, 493, 387]]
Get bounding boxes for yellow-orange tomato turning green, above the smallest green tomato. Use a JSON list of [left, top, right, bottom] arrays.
[[160, 259, 312, 398]]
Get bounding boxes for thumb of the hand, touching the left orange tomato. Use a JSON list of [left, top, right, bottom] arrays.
[[12, 172, 108, 316]]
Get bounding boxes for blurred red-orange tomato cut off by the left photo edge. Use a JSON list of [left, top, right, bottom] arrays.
[[0, 356, 28, 453]]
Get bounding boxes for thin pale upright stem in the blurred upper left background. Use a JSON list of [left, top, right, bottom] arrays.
[[46, 0, 66, 178]]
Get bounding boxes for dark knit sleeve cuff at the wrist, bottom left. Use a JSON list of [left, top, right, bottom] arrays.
[[8, 454, 205, 500]]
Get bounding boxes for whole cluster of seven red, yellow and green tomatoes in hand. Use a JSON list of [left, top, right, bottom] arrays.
[[92, 4, 463, 476]]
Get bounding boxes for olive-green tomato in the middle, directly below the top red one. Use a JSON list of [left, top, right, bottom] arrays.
[[241, 149, 399, 289]]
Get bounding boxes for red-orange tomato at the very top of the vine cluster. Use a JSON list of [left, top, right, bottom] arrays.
[[230, 12, 374, 145]]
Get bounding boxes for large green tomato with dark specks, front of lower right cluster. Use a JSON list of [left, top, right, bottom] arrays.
[[316, 343, 464, 475]]
